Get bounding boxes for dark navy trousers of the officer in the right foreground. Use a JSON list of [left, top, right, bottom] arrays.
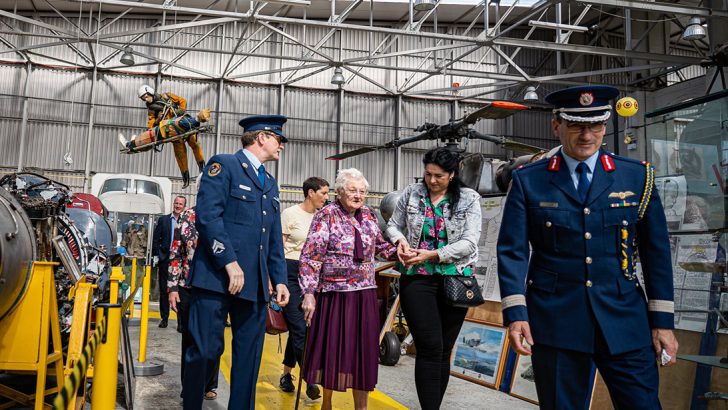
[[532, 329, 662, 410]]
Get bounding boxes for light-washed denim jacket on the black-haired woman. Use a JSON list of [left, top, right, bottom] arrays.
[[386, 183, 483, 273]]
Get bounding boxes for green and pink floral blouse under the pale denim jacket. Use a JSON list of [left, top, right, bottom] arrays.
[[397, 196, 472, 276]]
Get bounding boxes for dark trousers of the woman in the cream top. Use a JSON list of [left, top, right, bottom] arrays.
[[283, 259, 306, 367]]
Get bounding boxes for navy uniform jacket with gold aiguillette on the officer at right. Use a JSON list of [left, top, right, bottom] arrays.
[[497, 151, 674, 354]]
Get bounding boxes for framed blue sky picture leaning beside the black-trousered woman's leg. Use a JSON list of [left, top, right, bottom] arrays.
[[450, 319, 508, 388]]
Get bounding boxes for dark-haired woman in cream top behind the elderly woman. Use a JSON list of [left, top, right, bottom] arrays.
[[280, 177, 329, 400]]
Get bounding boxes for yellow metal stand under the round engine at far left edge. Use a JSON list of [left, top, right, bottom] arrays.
[[0, 262, 63, 410]]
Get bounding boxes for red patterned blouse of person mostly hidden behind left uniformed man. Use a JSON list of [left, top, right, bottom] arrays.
[[167, 208, 199, 292]]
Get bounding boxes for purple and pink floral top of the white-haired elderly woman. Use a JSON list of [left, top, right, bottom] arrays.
[[298, 201, 397, 295]]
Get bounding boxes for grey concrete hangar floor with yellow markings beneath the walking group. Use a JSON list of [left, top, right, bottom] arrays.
[[114, 312, 537, 410]]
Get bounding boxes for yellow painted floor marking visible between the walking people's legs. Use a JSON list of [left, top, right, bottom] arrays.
[[220, 328, 407, 410]]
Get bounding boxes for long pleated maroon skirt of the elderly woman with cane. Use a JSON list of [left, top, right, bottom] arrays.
[[304, 289, 379, 391]]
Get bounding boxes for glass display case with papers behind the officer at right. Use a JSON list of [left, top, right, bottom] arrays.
[[645, 90, 728, 333]]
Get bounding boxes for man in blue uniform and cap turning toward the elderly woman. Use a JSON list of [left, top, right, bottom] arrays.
[[183, 115, 289, 409]]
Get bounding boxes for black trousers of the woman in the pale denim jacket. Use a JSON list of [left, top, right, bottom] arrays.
[[399, 275, 468, 410]]
